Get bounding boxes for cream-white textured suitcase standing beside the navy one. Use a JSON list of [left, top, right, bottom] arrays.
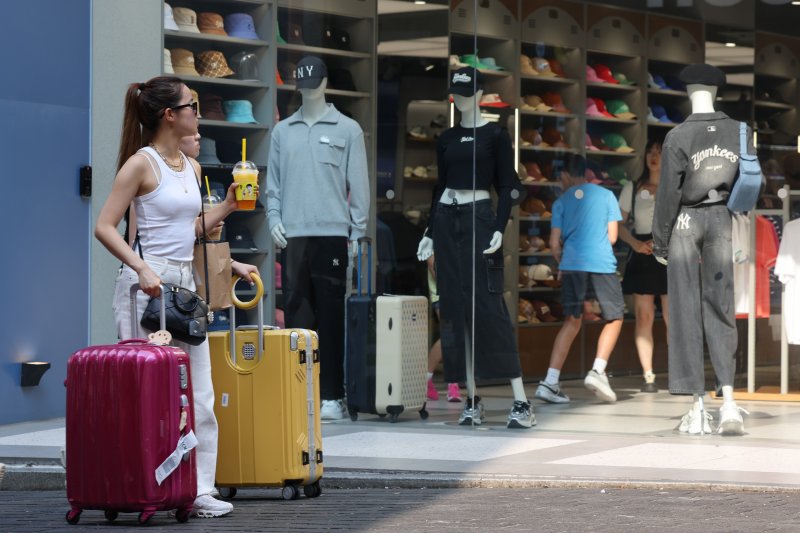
[[375, 295, 428, 422]]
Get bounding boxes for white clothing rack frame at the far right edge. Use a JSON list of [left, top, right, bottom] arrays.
[[747, 185, 800, 394]]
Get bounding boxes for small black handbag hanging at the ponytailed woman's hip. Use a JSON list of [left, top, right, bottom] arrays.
[[140, 283, 208, 346]]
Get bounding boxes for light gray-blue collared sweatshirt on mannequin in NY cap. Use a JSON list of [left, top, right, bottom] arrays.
[[267, 104, 370, 240]]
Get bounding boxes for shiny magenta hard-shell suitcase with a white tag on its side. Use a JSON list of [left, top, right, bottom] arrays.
[[65, 285, 197, 524]]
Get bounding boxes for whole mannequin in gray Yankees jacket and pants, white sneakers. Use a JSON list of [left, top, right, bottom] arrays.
[[653, 64, 752, 435]]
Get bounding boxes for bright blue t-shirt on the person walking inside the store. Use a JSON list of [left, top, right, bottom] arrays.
[[552, 183, 622, 274]]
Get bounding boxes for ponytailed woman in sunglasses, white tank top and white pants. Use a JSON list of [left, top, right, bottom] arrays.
[[95, 76, 258, 518]]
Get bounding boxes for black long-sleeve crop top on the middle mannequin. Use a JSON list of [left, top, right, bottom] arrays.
[[426, 122, 519, 238]]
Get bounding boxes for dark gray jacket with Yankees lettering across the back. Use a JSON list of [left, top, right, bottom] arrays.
[[653, 111, 755, 257]]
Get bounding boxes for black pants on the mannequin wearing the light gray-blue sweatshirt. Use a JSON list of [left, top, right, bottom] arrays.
[[281, 237, 347, 400]]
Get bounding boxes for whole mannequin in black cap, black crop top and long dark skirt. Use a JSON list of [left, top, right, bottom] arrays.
[[417, 67, 536, 428]]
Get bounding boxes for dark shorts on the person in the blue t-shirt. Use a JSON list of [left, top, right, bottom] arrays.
[[561, 270, 625, 320]]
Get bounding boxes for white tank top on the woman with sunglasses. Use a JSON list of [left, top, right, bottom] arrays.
[[133, 146, 201, 261]]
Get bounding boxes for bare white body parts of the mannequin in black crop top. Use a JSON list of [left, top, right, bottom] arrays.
[[417, 90, 528, 402]]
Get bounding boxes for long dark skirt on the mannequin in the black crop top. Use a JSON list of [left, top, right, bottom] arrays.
[[433, 200, 522, 383]]
